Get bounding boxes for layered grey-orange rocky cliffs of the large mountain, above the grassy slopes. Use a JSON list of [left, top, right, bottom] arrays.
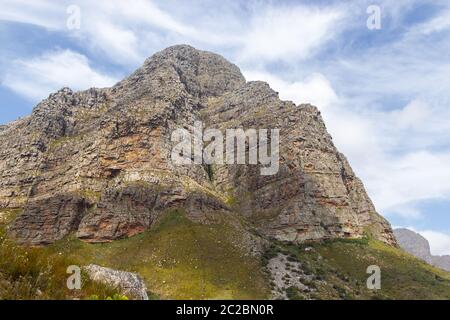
[[0, 46, 396, 245]]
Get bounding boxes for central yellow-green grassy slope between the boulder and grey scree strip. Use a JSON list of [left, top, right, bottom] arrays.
[[42, 211, 268, 299]]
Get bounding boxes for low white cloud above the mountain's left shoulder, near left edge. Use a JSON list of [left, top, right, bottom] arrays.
[[3, 50, 116, 101]]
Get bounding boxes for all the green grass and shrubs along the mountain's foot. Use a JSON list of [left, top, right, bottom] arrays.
[[0, 210, 450, 300]]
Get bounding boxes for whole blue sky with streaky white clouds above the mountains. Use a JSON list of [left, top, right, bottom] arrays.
[[0, 0, 450, 254]]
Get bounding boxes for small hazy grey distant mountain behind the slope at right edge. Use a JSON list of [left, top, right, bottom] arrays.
[[394, 228, 450, 271]]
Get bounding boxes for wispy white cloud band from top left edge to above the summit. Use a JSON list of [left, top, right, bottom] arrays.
[[0, 0, 199, 67]]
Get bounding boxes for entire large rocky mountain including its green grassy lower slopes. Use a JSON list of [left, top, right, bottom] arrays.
[[0, 45, 450, 299]]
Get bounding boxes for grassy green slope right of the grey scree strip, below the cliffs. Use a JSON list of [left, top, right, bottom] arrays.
[[266, 239, 450, 299]]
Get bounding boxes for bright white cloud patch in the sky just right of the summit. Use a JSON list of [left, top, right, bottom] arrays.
[[239, 6, 344, 62]]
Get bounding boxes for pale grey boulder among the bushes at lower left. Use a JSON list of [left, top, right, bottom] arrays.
[[83, 264, 148, 300]]
